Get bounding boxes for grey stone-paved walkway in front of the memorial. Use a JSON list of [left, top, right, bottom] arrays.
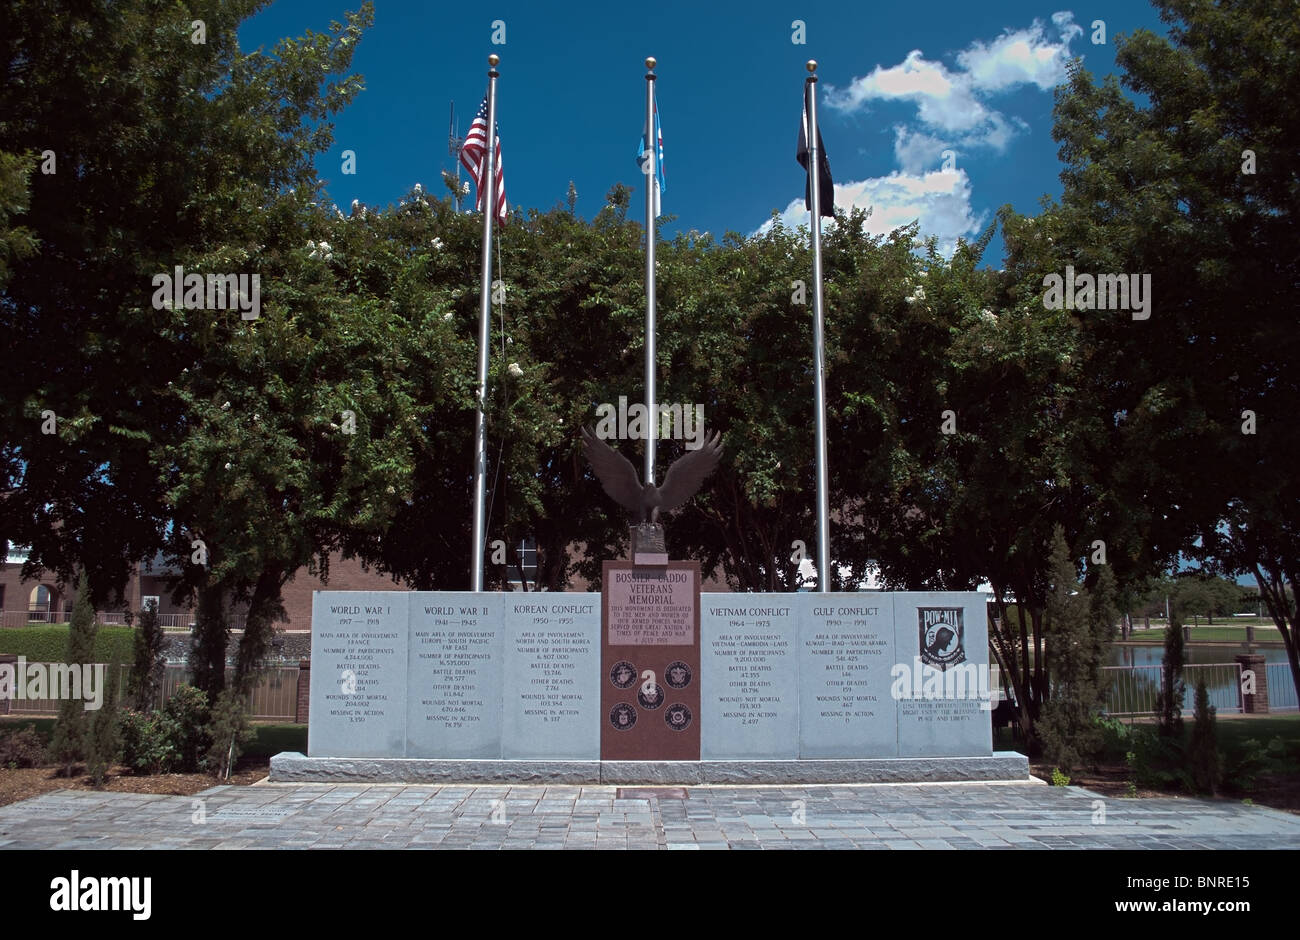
[[0, 783, 1300, 849]]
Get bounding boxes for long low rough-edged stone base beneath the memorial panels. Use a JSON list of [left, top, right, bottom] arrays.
[[269, 751, 1030, 785]]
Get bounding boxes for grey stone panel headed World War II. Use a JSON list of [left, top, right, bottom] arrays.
[[406, 590, 504, 758]]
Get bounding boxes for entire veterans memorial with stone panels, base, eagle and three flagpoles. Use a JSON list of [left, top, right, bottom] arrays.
[[270, 55, 1028, 784]]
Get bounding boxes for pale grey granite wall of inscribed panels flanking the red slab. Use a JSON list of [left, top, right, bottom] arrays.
[[308, 592, 992, 761]]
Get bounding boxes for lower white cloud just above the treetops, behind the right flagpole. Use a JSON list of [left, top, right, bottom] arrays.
[[755, 169, 983, 256]]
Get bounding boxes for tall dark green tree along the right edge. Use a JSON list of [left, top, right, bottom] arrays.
[[1040, 0, 1300, 707]]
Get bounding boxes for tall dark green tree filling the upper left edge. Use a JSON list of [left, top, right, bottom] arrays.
[[0, 0, 372, 618]]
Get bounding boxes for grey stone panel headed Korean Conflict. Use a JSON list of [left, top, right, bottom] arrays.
[[498, 593, 601, 761]]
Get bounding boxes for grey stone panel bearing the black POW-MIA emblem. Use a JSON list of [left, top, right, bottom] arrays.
[[891, 592, 993, 757]]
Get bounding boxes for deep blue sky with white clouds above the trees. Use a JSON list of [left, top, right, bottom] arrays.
[[241, 0, 1165, 267]]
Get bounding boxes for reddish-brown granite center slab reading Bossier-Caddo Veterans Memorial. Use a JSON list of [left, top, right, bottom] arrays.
[[601, 562, 701, 761]]
